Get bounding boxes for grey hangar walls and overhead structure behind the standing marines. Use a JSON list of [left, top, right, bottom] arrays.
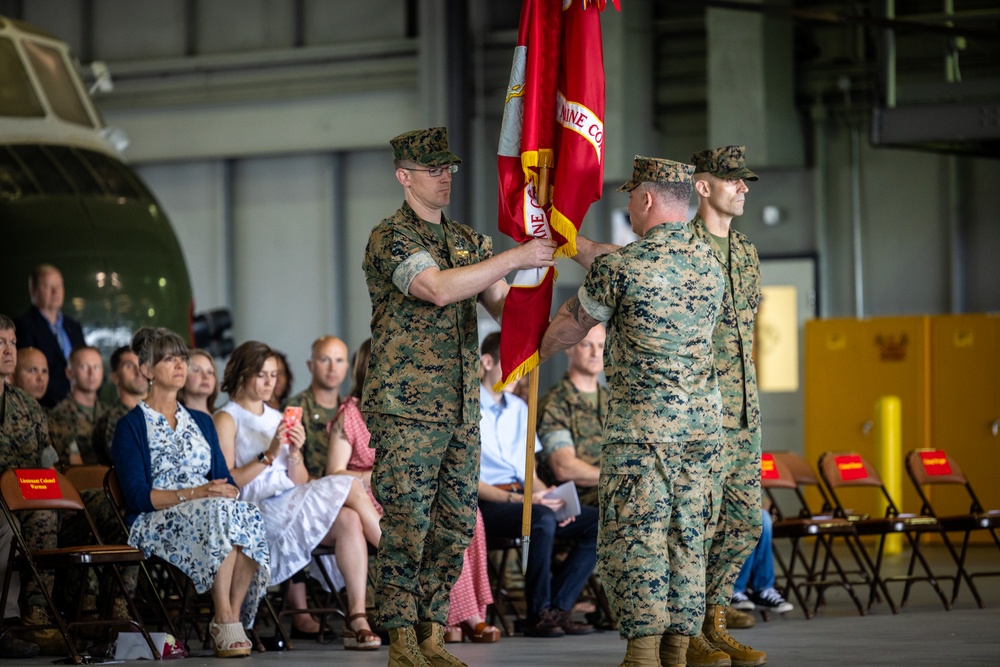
[[0, 0, 1000, 451]]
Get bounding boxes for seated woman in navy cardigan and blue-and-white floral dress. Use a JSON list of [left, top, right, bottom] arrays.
[[111, 327, 270, 657]]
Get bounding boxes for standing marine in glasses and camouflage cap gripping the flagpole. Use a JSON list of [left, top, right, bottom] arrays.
[[361, 127, 555, 665]]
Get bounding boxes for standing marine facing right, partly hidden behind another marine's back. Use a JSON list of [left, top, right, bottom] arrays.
[[688, 146, 766, 667]]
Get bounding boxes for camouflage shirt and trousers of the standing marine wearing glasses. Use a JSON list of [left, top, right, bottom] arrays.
[[362, 203, 493, 628]]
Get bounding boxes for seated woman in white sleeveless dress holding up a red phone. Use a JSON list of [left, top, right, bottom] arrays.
[[212, 341, 382, 650]]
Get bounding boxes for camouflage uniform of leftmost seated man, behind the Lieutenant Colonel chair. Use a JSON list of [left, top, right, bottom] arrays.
[[0, 385, 59, 609]]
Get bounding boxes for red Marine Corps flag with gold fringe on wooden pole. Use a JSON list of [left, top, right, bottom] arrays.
[[497, 0, 618, 392]]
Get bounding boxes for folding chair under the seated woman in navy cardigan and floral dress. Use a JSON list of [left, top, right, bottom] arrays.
[[103, 468, 292, 653]]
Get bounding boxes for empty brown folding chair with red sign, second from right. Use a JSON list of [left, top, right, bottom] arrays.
[[819, 452, 958, 614]]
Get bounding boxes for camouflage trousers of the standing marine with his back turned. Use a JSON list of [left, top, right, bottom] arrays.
[[598, 440, 718, 639]]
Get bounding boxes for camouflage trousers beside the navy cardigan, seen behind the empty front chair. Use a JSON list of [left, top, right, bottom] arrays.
[[59, 489, 139, 602]]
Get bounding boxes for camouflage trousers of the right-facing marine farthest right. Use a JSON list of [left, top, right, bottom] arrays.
[[705, 428, 761, 605]]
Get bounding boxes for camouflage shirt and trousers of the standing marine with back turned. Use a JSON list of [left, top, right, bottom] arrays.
[[578, 222, 725, 639]]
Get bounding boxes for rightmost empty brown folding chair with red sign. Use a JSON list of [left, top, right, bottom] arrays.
[[906, 449, 1000, 609]]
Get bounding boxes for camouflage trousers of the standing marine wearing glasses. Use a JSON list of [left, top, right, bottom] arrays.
[[368, 414, 479, 628]]
